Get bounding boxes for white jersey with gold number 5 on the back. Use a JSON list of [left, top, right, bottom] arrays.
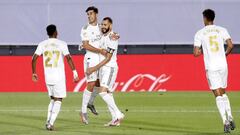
[[194, 25, 231, 70]]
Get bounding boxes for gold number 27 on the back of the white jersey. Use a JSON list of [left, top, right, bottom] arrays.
[[44, 51, 60, 67]]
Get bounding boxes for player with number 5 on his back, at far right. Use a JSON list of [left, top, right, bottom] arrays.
[[193, 9, 235, 133]]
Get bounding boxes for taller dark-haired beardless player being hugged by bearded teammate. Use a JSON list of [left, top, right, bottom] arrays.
[[80, 6, 119, 124]]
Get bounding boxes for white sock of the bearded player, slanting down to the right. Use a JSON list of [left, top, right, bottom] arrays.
[[99, 92, 122, 118]]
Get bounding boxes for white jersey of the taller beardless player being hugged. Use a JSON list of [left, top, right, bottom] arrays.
[[80, 24, 102, 59]]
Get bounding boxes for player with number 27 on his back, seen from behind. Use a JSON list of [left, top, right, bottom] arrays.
[[32, 24, 79, 130]]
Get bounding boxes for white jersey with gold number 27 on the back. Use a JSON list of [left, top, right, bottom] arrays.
[[35, 38, 69, 84]]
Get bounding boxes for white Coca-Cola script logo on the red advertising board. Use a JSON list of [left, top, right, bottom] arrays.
[[73, 74, 171, 92]]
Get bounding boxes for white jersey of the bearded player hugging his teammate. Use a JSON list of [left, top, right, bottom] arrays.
[[100, 32, 118, 67]]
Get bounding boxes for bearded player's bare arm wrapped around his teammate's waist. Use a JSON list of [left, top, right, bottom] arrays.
[[86, 53, 113, 75]]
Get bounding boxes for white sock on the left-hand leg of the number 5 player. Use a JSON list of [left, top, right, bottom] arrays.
[[216, 96, 227, 124]]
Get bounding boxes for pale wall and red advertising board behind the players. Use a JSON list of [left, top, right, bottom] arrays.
[[0, 0, 240, 91]]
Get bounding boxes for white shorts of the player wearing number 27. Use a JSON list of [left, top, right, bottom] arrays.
[[46, 80, 67, 98]]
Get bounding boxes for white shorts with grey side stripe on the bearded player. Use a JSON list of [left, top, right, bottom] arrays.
[[99, 66, 118, 92]]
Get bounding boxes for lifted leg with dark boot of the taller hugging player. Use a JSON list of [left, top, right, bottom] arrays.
[[87, 79, 100, 115]]
